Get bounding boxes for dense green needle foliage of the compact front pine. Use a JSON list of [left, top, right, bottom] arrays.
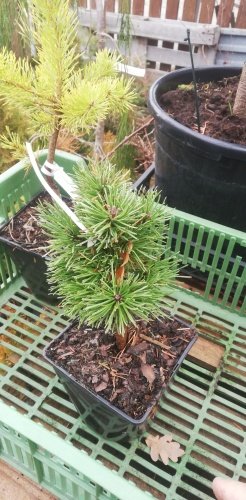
[[39, 161, 177, 334]]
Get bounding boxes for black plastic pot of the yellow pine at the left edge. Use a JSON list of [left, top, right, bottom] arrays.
[[0, 195, 58, 303]]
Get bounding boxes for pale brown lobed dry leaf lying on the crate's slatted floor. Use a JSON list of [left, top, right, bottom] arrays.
[[146, 434, 184, 465]]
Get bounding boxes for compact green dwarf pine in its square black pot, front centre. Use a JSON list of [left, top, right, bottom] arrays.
[[38, 161, 196, 440]]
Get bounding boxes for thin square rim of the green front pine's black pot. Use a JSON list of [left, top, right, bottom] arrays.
[[42, 316, 198, 425]]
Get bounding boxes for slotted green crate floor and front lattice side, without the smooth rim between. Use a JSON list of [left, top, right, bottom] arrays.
[[0, 279, 246, 500]]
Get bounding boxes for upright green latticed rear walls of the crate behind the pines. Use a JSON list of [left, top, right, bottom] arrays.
[[0, 150, 246, 315]]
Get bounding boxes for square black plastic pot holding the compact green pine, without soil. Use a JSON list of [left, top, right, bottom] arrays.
[[43, 318, 197, 441]]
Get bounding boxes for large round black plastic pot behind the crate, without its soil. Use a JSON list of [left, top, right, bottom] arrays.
[[149, 66, 246, 231]]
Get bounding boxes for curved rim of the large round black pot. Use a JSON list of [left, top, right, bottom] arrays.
[[148, 65, 246, 155]]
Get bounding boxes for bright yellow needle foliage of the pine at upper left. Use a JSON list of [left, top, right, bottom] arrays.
[[0, 0, 136, 161]]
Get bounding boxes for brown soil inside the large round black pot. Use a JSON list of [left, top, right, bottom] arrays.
[[160, 76, 246, 146]]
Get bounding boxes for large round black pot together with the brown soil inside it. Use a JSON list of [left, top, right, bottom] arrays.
[[149, 66, 246, 231]]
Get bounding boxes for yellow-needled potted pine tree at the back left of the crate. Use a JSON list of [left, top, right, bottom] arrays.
[[0, 0, 135, 297]]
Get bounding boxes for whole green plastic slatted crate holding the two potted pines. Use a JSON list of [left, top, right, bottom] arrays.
[[0, 153, 246, 500]]
